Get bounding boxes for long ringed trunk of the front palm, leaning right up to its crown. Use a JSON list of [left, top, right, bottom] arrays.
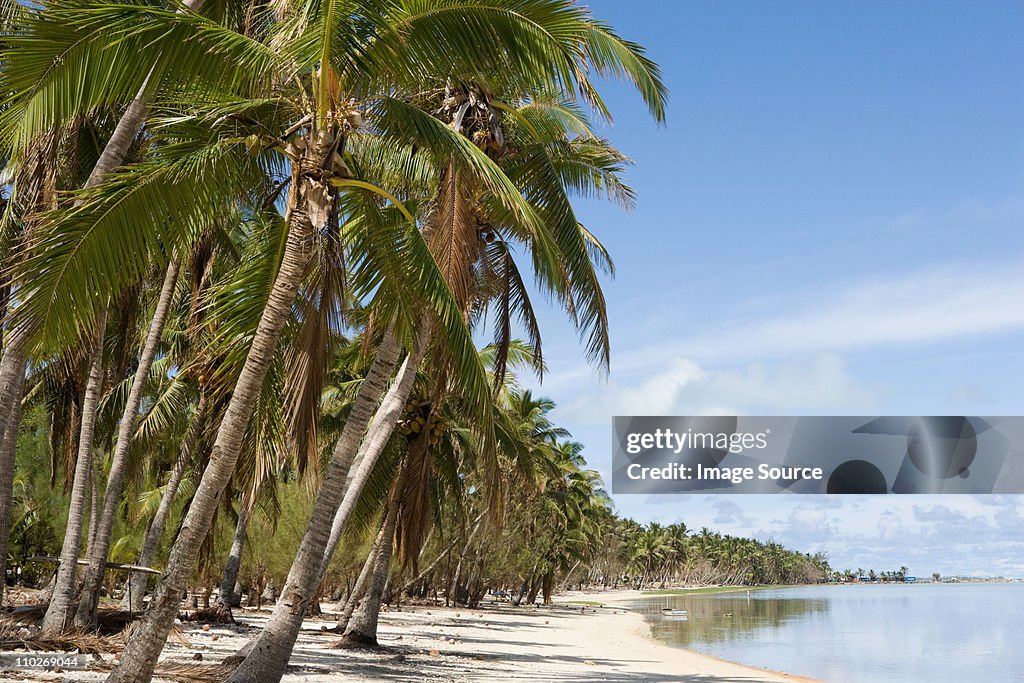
[[108, 179, 315, 683]]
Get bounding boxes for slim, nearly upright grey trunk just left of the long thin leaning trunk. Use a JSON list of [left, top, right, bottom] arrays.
[[43, 306, 106, 634]]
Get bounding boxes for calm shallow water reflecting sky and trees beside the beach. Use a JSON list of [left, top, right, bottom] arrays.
[[637, 583, 1024, 683]]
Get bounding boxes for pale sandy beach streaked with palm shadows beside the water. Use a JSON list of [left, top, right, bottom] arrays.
[[0, 591, 809, 683]]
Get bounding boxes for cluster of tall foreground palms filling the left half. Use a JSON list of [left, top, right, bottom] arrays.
[[0, 0, 666, 681]]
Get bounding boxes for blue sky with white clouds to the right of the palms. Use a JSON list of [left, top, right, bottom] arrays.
[[524, 0, 1024, 577]]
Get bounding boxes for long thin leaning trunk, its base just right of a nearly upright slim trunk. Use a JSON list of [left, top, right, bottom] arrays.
[[75, 255, 180, 629]]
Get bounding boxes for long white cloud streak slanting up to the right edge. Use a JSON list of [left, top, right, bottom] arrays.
[[615, 261, 1024, 371]]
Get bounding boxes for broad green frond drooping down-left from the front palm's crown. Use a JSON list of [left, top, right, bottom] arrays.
[[11, 133, 265, 347]]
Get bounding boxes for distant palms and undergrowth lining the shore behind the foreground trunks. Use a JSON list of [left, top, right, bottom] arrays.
[[4, 368, 834, 626]]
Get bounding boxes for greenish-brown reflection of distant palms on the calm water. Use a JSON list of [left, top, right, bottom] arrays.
[[636, 591, 829, 646]]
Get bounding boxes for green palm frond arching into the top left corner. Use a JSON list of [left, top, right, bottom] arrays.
[[0, 0, 280, 146]]
